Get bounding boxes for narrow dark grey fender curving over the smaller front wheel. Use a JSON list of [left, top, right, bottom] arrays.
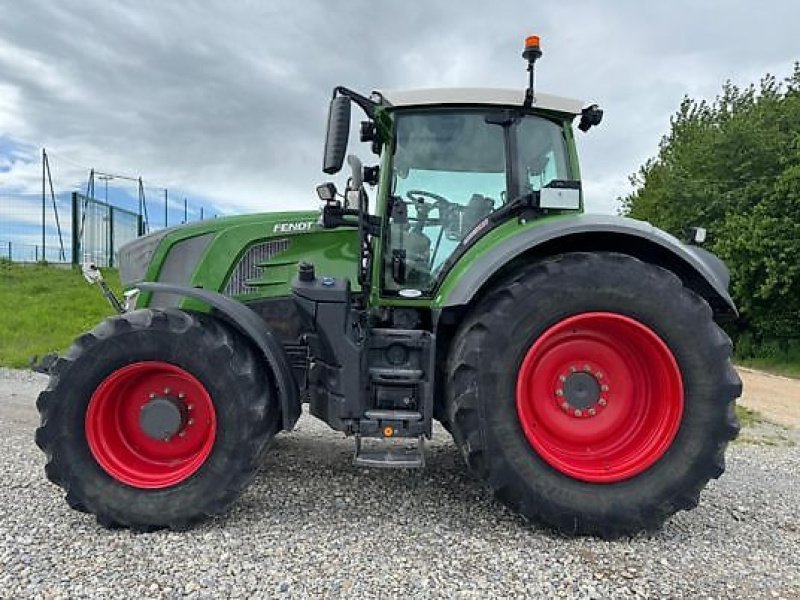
[[136, 281, 302, 431]]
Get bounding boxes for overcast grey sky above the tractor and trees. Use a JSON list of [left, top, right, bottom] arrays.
[[0, 0, 800, 212]]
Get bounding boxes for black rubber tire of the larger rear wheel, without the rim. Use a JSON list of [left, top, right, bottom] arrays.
[[447, 253, 741, 538]]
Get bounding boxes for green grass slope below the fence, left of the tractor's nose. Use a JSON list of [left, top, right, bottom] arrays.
[[0, 261, 120, 367]]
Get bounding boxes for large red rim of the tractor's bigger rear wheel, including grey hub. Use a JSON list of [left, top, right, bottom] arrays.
[[517, 312, 683, 483]]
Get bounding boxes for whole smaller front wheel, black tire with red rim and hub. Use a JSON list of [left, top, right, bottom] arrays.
[[36, 309, 279, 530]]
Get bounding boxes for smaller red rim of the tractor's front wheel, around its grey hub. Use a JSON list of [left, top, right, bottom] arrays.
[[85, 362, 217, 489]]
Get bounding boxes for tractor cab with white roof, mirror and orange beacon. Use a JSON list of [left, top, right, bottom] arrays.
[[318, 39, 602, 299]]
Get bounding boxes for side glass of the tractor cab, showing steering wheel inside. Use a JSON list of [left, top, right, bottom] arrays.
[[384, 109, 570, 295]]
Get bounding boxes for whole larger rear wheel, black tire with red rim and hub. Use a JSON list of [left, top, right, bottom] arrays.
[[448, 253, 741, 537]]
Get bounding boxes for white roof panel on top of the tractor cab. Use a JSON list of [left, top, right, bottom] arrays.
[[375, 88, 584, 115]]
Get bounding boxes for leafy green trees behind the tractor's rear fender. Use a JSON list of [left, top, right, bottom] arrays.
[[622, 63, 800, 343]]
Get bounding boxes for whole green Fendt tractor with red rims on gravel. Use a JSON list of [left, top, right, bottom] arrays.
[[36, 37, 741, 537]]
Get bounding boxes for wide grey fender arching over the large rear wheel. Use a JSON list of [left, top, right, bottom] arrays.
[[437, 215, 738, 316]]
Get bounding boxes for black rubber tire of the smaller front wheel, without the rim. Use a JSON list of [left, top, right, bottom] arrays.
[[36, 309, 280, 531]]
